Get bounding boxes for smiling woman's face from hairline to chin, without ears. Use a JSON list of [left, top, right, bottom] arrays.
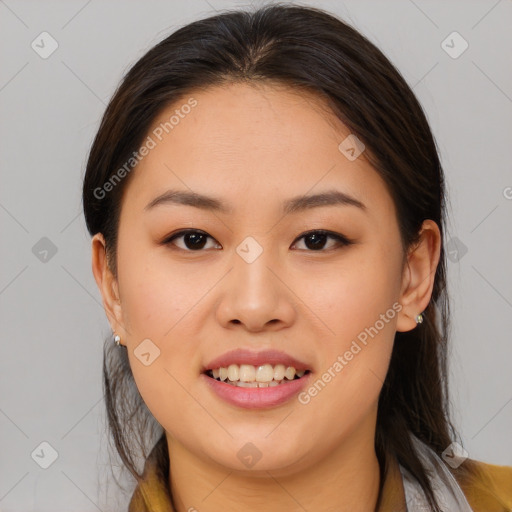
[[95, 84, 421, 474]]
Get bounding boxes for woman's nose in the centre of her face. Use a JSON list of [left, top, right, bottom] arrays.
[[217, 247, 296, 332]]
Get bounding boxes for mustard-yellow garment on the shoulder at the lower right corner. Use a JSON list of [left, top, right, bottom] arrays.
[[452, 459, 512, 512]]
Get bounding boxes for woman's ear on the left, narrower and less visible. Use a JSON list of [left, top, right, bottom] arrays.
[[92, 233, 126, 346]]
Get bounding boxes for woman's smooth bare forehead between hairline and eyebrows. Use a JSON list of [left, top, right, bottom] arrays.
[[122, 83, 391, 220]]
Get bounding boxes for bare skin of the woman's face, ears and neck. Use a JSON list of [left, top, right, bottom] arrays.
[[92, 84, 440, 512]]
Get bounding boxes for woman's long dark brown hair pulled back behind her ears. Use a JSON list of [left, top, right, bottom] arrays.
[[83, 4, 482, 511]]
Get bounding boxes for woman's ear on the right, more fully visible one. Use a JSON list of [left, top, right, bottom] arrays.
[[396, 219, 441, 332]]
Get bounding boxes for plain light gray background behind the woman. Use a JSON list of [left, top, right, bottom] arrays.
[[0, 0, 512, 512]]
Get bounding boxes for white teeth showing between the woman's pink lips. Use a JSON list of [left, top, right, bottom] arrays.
[[209, 364, 306, 388]]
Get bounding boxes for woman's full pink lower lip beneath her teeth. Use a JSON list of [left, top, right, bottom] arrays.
[[200, 373, 311, 409]]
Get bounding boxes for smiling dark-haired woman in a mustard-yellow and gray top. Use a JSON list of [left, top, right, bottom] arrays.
[[83, 5, 512, 512]]
